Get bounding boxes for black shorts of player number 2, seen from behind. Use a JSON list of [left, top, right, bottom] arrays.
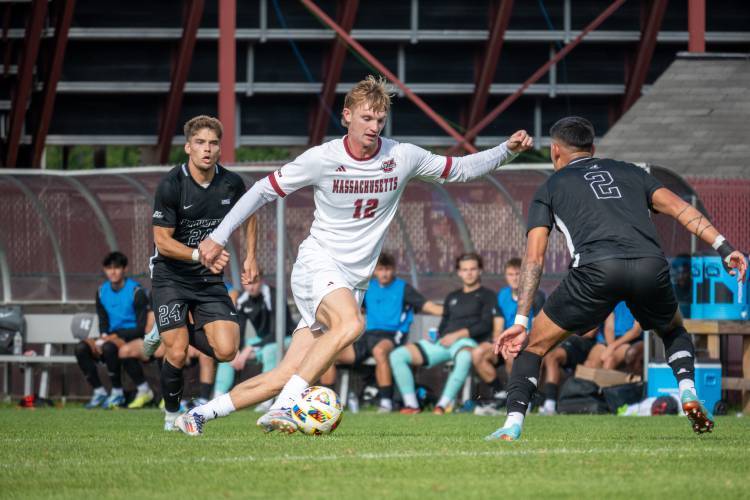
[[543, 257, 677, 334]]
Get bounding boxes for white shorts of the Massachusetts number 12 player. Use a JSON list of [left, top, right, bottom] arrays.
[[292, 238, 366, 332]]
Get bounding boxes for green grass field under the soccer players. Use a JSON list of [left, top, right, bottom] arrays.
[[0, 407, 750, 499]]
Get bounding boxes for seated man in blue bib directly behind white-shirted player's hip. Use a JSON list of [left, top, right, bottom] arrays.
[[321, 253, 443, 413]]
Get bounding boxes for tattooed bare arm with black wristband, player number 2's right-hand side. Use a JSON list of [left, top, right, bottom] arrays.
[[651, 188, 747, 283]]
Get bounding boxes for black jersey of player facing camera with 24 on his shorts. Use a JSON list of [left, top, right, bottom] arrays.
[[151, 164, 245, 283]]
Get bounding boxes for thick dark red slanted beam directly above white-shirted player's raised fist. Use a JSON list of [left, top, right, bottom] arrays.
[[467, 0, 513, 128]]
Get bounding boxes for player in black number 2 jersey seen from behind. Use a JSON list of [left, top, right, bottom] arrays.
[[487, 117, 747, 441]]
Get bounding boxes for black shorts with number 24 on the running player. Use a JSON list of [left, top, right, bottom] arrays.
[[151, 282, 239, 333]]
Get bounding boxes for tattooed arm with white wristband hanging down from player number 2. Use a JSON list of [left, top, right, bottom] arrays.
[[494, 227, 549, 359]]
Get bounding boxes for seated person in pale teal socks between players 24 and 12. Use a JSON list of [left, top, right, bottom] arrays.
[[214, 270, 296, 412]]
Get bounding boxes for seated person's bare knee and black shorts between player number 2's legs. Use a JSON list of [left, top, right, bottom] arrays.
[[539, 328, 598, 415]]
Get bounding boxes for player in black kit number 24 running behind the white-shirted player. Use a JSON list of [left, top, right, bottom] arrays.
[[150, 116, 258, 430]]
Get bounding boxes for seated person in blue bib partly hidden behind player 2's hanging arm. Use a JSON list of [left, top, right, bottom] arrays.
[[472, 257, 544, 415]]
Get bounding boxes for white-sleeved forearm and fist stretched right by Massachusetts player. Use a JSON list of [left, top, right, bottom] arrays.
[[446, 130, 534, 182]]
